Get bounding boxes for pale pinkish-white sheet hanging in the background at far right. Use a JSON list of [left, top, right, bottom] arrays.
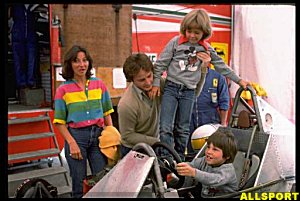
[[230, 4, 296, 123]]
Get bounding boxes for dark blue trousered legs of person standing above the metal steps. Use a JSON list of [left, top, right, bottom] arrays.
[[9, 4, 37, 90]]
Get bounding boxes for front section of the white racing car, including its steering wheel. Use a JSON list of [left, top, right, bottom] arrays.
[[84, 142, 184, 198]]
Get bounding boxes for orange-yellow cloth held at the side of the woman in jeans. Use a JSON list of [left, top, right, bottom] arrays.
[[99, 126, 121, 161]]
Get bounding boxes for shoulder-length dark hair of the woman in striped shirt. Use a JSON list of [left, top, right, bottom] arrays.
[[61, 45, 93, 80]]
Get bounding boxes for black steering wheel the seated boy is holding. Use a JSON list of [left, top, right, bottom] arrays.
[[152, 142, 185, 189]]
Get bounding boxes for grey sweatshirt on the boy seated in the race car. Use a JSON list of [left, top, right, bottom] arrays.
[[189, 156, 238, 197]]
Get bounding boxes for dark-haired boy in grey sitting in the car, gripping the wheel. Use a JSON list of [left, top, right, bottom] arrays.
[[176, 127, 238, 197]]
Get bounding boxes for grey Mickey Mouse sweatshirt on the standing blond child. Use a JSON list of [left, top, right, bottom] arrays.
[[153, 36, 241, 89]]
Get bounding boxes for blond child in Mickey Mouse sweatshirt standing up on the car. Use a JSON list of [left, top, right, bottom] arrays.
[[149, 9, 248, 161]]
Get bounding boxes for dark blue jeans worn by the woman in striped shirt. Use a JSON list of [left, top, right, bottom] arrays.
[[65, 125, 107, 198]]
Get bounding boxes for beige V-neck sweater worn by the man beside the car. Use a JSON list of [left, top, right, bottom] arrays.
[[118, 79, 164, 148]]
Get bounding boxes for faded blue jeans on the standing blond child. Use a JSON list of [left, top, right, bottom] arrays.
[[160, 81, 195, 161]]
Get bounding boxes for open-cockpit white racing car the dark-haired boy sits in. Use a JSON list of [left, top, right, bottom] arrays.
[[84, 86, 296, 199]]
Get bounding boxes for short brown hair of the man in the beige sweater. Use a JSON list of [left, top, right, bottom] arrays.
[[123, 53, 153, 82]]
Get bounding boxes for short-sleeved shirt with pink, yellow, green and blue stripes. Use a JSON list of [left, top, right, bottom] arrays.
[[53, 77, 114, 128]]
